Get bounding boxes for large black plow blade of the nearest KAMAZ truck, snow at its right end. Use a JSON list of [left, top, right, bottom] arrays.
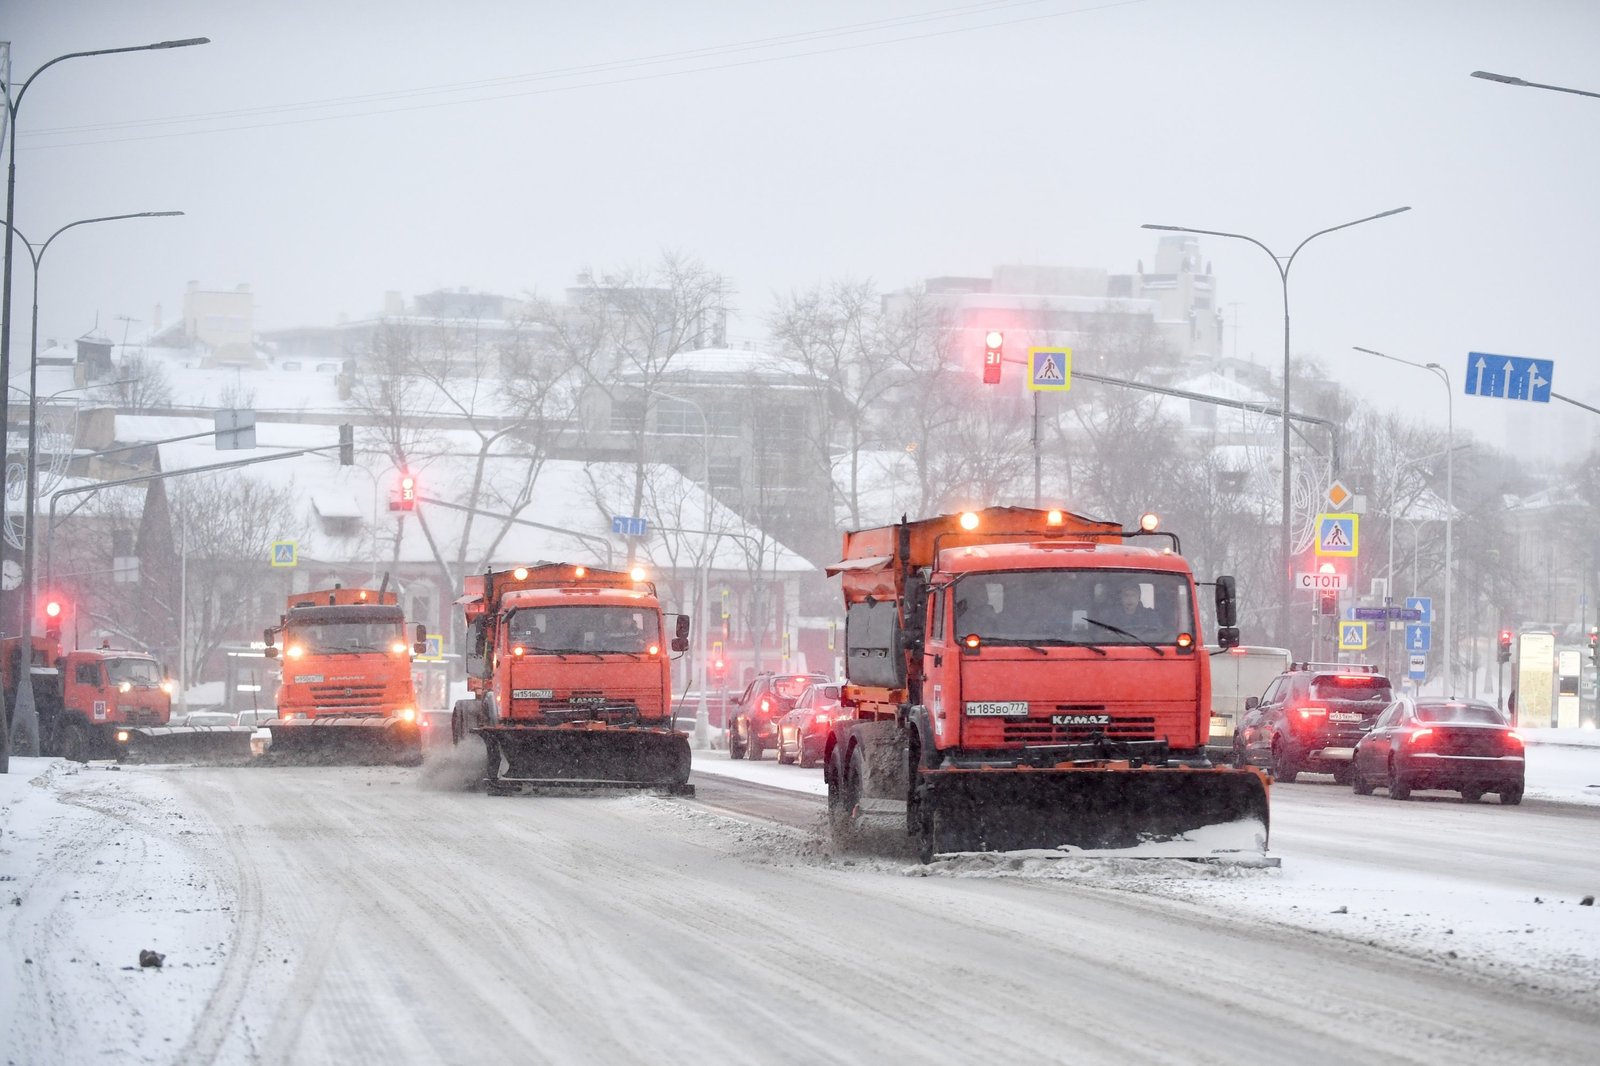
[[922, 767, 1269, 858]]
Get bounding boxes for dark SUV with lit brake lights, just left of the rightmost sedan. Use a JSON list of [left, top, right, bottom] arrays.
[[1234, 663, 1394, 784]]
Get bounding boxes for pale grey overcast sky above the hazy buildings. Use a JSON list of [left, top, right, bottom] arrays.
[[9, 0, 1600, 457]]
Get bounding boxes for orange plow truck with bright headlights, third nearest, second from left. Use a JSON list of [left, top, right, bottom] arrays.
[[262, 578, 427, 765]]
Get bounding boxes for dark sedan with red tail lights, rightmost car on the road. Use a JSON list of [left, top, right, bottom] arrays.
[[1350, 696, 1526, 805]]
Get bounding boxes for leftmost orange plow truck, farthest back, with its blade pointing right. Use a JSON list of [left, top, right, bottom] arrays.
[[0, 637, 250, 763]]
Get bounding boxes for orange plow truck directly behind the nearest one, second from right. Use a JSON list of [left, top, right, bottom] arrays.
[[451, 563, 694, 795]]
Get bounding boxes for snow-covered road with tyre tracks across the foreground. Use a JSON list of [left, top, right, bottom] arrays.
[[0, 745, 1600, 1063]]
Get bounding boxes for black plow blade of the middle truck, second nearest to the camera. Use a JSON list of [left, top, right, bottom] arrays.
[[472, 725, 694, 795]]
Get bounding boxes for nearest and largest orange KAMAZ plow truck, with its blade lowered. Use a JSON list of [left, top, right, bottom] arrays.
[[824, 507, 1267, 863]]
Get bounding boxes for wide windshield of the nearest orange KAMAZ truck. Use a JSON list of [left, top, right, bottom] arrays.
[[952, 570, 1195, 645]]
